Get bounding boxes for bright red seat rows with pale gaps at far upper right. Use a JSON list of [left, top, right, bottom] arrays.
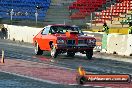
[[95, 0, 132, 24]]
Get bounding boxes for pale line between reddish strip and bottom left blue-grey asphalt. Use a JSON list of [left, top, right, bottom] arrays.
[[0, 70, 60, 84]]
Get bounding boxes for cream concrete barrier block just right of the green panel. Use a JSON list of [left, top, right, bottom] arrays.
[[107, 34, 127, 55]]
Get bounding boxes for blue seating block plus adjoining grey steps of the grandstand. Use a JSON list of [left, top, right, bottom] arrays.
[[0, 0, 75, 26]]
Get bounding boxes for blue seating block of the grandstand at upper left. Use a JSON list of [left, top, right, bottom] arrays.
[[0, 0, 51, 26]]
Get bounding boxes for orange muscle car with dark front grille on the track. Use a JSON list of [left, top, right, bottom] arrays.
[[33, 24, 96, 59]]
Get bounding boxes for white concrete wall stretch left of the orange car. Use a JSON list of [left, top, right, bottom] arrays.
[[4, 24, 43, 43]]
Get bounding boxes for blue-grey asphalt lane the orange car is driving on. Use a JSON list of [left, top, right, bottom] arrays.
[[0, 40, 132, 88]]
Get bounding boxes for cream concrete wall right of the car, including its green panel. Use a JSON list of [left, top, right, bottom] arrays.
[[85, 31, 132, 56]]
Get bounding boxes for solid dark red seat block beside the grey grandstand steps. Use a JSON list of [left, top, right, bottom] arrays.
[[69, 0, 106, 19]]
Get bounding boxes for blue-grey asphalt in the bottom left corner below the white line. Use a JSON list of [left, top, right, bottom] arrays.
[[0, 72, 94, 88]]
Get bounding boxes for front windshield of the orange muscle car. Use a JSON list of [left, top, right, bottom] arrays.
[[51, 26, 82, 34]]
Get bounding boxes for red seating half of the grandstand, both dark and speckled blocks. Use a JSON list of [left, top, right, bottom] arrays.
[[69, 0, 132, 28]]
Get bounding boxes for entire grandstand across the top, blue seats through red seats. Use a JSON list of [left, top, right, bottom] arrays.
[[0, 0, 132, 28]]
